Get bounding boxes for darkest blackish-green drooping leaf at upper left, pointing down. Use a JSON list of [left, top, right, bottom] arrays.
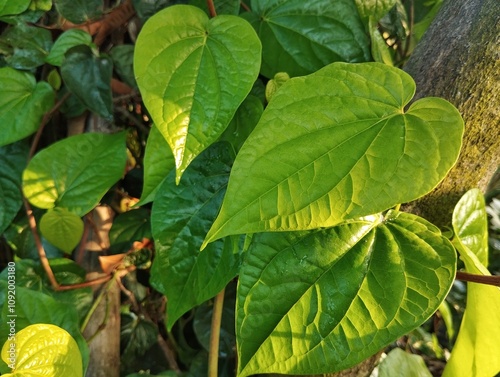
[[61, 45, 113, 120]]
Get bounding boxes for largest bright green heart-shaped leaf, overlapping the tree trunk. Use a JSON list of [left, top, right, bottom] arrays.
[[202, 63, 463, 242]]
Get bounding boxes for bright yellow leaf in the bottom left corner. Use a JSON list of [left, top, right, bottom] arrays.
[[2, 324, 83, 377]]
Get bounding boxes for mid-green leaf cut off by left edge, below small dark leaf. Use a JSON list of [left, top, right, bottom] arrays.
[[0, 67, 54, 146]]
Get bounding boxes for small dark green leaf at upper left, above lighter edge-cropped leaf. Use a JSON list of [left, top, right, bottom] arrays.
[[2, 23, 52, 70]]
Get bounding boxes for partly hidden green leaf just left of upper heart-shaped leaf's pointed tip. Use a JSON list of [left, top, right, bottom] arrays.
[[137, 125, 175, 206]]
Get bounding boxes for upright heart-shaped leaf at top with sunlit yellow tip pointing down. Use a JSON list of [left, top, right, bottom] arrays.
[[134, 5, 261, 183]]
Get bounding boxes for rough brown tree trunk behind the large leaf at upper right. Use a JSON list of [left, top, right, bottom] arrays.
[[403, 0, 500, 227]]
